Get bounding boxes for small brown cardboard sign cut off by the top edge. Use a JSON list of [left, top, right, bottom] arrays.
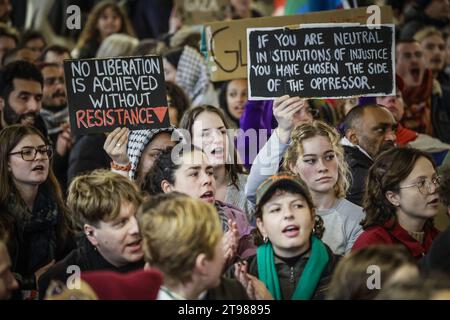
[[175, 0, 230, 25]]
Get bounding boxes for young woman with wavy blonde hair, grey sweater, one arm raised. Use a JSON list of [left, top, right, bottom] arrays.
[[246, 101, 364, 254]]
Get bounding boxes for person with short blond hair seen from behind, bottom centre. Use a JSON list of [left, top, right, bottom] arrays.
[[138, 192, 247, 300]]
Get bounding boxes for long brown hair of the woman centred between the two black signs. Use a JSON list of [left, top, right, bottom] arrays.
[[179, 104, 244, 189]]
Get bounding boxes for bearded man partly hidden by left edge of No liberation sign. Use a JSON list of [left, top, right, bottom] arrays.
[[40, 63, 73, 190]]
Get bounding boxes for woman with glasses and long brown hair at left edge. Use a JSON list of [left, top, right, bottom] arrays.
[[0, 125, 74, 298]]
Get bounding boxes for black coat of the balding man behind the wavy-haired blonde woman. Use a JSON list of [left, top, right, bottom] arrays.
[[343, 146, 373, 206]]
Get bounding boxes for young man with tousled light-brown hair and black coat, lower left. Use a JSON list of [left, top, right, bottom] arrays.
[[39, 170, 144, 297]]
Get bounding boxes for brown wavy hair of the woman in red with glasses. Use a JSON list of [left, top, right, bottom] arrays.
[[361, 148, 436, 229]]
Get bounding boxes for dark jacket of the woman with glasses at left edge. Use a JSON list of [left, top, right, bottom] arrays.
[[0, 186, 75, 290]]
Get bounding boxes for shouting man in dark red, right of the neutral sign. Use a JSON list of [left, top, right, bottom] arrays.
[[396, 40, 450, 143]]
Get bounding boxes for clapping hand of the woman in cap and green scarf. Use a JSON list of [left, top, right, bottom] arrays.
[[234, 261, 273, 300]]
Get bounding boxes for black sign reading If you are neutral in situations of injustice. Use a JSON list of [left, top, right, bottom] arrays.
[[247, 23, 395, 100]]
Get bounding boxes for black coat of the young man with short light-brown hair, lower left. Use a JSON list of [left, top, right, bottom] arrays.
[[38, 236, 144, 299]]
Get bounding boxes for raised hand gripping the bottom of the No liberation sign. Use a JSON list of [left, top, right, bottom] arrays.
[[103, 128, 130, 166]]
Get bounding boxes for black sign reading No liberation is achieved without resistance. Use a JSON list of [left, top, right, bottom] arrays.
[[64, 56, 169, 134]]
